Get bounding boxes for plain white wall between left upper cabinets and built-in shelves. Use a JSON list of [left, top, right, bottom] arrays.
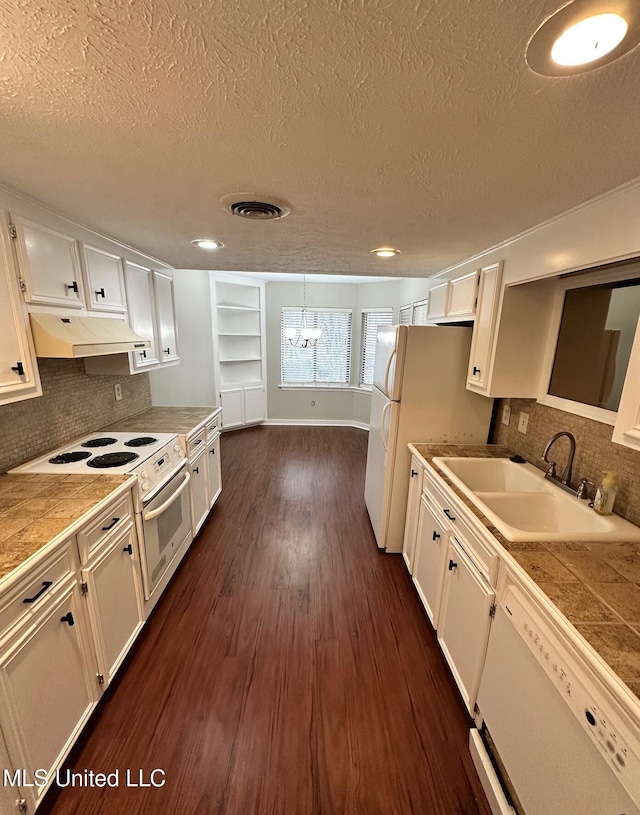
[[149, 269, 220, 407]]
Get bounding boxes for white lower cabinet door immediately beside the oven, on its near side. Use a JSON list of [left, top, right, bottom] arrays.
[[82, 524, 144, 688]]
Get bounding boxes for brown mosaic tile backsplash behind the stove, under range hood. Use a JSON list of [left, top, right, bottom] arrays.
[[0, 359, 151, 473]]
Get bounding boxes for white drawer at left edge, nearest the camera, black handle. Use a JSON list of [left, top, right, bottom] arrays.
[[0, 537, 78, 636]]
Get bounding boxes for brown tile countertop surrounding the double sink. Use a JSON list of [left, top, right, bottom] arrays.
[[411, 444, 640, 698]]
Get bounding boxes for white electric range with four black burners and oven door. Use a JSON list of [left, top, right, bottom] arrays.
[[11, 432, 192, 600]]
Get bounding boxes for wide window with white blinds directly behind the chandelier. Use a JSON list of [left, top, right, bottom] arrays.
[[280, 308, 351, 385]]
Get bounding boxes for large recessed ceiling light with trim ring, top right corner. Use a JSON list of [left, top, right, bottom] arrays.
[[526, 0, 640, 76]]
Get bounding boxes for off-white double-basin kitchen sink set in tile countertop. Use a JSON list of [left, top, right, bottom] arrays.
[[433, 457, 640, 541]]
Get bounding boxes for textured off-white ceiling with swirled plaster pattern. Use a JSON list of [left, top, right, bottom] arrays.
[[0, 0, 640, 276]]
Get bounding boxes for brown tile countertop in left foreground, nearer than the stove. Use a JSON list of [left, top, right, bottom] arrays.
[[0, 473, 131, 580]]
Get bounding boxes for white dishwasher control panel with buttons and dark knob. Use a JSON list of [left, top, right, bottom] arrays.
[[501, 587, 640, 804]]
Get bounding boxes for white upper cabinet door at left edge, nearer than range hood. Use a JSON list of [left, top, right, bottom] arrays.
[[0, 215, 42, 405]]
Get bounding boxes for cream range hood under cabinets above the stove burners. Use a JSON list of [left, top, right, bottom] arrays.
[[29, 312, 151, 359]]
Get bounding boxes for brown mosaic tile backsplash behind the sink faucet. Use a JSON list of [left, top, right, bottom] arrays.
[[491, 399, 640, 526]]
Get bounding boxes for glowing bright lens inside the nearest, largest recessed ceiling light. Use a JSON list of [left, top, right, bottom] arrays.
[[551, 14, 629, 66]]
